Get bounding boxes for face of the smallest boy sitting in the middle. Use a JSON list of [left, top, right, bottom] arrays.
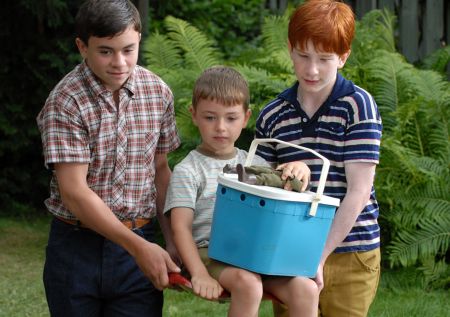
[[190, 99, 251, 155]]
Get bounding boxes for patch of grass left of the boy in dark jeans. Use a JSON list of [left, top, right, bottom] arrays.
[[0, 219, 49, 317]]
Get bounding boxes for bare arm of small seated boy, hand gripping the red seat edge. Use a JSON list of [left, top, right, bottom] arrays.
[[170, 207, 223, 299]]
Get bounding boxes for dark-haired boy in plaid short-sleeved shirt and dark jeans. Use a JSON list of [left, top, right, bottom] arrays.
[[37, 0, 180, 316]]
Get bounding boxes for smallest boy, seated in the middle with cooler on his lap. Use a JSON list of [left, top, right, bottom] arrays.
[[164, 67, 319, 317]]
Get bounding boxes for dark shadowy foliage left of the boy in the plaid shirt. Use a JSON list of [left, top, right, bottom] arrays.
[[0, 0, 79, 215]]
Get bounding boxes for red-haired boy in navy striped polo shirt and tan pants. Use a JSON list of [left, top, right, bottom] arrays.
[[256, 0, 382, 317]]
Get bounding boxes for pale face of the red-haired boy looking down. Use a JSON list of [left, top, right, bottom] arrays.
[[289, 41, 350, 96]]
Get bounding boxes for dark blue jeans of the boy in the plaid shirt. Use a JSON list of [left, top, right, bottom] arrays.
[[44, 218, 163, 317]]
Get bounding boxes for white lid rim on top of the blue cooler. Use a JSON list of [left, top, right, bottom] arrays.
[[217, 173, 340, 207]]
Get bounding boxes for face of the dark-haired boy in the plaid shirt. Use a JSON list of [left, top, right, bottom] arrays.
[[76, 27, 141, 92]]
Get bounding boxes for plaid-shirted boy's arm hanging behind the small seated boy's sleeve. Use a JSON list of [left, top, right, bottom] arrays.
[[155, 154, 181, 265]]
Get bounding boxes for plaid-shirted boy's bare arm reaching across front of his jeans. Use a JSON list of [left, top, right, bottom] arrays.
[[55, 163, 179, 290]]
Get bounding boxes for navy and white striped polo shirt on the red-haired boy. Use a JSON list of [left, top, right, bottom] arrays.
[[256, 74, 382, 253]]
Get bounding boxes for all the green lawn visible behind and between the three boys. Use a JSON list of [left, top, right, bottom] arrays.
[[0, 218, 450, 317]]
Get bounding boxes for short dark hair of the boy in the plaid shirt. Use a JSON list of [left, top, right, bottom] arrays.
[[75, 0, 141, 45]]
